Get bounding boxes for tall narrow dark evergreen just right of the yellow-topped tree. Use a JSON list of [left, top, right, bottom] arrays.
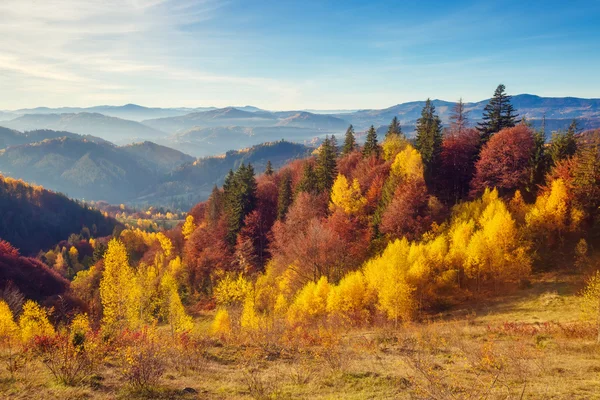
[[415, 99, 442, 179]]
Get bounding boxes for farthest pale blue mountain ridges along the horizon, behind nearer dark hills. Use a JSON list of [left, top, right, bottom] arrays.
[[0, 94, 600, 156]]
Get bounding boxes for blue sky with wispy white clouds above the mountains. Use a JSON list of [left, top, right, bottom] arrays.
[[0, 0, 600, 110]]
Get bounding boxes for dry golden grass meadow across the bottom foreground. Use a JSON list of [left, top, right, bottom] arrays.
[[0, 275, 600, 399]]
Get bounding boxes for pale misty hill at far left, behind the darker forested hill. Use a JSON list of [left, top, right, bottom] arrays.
[[2, 112, 164, 144]]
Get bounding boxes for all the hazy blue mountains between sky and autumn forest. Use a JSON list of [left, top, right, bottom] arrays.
[[0, 94, 600, 205]]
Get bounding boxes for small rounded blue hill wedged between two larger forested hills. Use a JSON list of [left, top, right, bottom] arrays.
[[121, 141, 195, 173]]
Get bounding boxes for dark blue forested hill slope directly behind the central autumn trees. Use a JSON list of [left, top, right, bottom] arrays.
[[136, 141, 312, 209]]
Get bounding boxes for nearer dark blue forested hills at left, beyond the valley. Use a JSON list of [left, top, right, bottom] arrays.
[[0, 128, 310, 209]]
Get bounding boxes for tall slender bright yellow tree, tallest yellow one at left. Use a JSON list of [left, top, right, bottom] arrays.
[[100, 239, 141, 331]]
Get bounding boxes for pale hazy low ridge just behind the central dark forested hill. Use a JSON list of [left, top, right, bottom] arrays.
[[161, 126, 327, 157]]
